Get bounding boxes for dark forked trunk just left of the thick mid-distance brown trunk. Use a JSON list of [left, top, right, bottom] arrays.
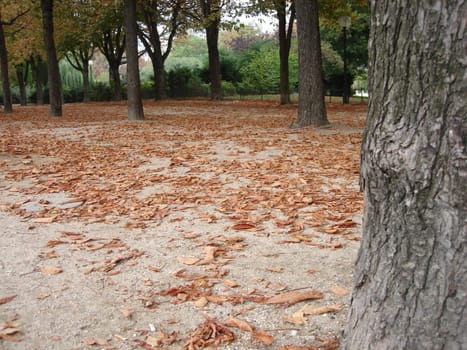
[[275, 0, 295, 105]]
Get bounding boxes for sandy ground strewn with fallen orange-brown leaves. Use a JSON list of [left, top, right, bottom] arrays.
[[0, 100, 366, 350]]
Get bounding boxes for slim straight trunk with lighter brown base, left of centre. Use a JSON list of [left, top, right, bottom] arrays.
[[123, 0, 144, 120]]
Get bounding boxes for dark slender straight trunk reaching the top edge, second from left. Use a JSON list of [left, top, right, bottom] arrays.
[[41, 0, 62, 117]]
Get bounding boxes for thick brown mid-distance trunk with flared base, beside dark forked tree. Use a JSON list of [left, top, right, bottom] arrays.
[[292, 0, 329, 128]]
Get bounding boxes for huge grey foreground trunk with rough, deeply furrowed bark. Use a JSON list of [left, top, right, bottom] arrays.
[[344, 0, 467, 350]]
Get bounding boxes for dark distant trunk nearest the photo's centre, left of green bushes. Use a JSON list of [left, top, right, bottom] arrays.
[[206, 20, 222, 100]]
